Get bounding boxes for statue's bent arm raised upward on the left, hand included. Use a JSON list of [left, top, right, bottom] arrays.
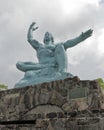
[[27, 22, 40, 49]]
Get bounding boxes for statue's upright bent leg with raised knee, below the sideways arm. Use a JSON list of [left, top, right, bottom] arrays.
[[55, 44, 67, 73]]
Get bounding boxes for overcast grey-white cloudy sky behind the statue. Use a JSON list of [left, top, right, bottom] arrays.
[[0, 0, 104, 88]]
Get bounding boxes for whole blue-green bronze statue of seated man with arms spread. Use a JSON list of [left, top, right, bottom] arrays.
[[15, 22, 93, 87]]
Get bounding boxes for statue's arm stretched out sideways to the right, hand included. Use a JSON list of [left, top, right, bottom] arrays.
[[63, 29, 93, 49]]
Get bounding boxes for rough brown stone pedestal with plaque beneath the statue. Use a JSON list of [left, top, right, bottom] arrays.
[[0, 77, 104, 130]]
